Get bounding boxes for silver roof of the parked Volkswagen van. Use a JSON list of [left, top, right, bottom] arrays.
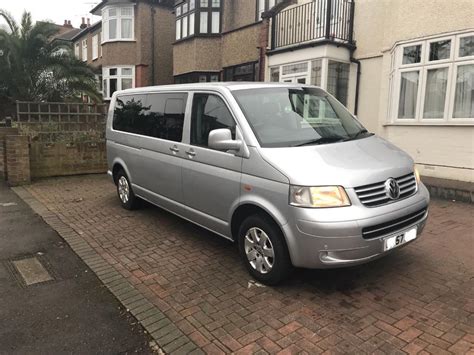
[[115, 81, 314, 94]]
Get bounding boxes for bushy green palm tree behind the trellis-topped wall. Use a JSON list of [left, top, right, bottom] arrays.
[[0, 9, 101, 102]]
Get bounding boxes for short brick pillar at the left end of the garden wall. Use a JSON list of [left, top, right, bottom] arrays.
[[5, 135, 30, 186]]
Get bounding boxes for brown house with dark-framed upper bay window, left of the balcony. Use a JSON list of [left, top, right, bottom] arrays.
[[173, 0, 286, 83]]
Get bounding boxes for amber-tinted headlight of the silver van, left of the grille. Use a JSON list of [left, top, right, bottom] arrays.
[[290, 186, 351, 208]]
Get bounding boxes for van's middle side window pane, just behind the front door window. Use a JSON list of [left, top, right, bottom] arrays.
[[146, 93, 188, 142]]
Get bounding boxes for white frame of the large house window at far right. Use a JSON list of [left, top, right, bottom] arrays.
[[388, 31, 474, 125]]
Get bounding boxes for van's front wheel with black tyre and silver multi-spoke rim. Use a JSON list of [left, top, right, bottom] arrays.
[[239, 215, 293, 285]]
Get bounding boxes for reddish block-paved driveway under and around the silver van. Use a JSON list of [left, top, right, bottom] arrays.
[[20, 175, 474, 354]]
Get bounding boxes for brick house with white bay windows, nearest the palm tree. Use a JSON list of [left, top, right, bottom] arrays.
[[72, 0, 174, 100]]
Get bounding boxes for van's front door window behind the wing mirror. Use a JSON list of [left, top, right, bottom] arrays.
[[191, 94, 235, 147]]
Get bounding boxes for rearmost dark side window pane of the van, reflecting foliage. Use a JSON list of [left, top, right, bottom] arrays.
[[112, 95, 148, 134]]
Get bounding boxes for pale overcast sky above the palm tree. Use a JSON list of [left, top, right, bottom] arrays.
[[0, 0, 100, 28]]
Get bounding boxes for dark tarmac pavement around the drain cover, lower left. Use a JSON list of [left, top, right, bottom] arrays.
[[0, 182, 152, 354]]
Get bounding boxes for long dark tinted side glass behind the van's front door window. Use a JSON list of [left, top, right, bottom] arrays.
[[113, 93, 187, 142]]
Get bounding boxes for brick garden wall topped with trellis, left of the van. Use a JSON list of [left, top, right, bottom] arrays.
[[0, 102, 107, 185]]
